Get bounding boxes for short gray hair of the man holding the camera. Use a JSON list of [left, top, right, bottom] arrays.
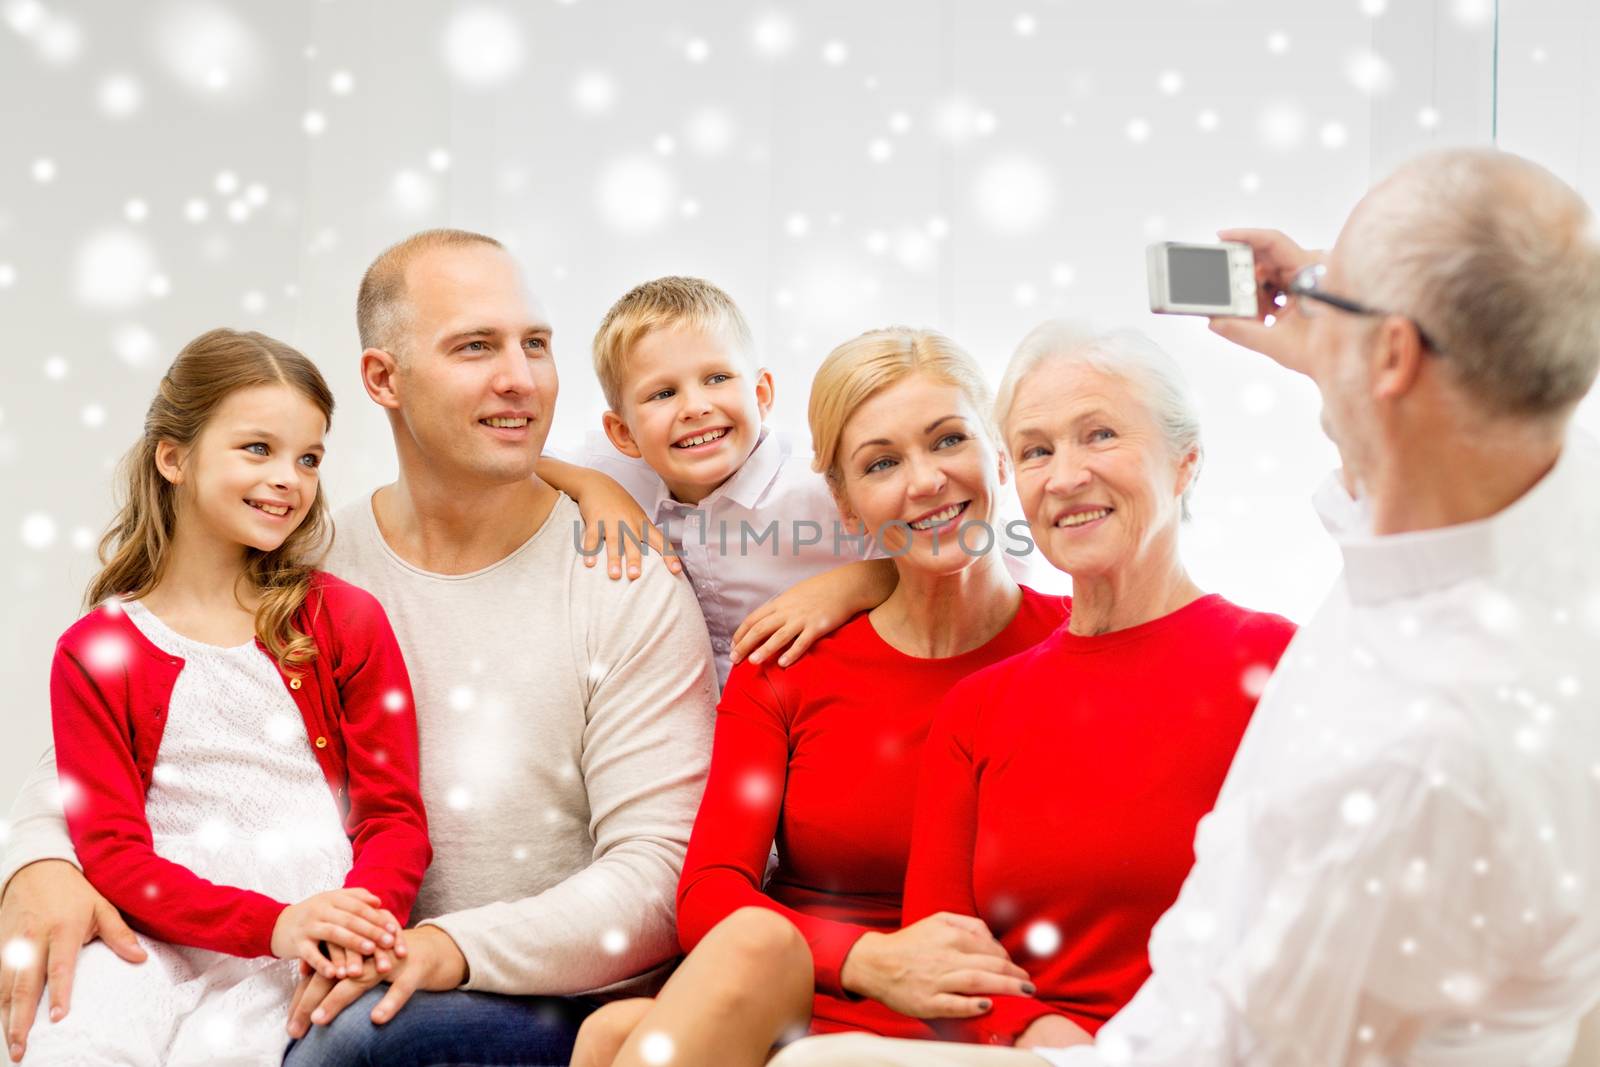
[[1339, 149, 1600, 421]]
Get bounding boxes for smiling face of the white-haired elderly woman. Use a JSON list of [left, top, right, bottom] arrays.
[[1003, 357, 1198, 579]]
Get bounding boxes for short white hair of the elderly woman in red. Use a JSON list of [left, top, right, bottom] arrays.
[[995, 318, 1205, 522]]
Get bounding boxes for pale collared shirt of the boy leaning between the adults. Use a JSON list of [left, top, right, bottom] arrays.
[[546, 427, 1053, 683]]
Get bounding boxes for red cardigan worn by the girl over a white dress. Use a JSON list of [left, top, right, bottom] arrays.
[[50, 573, 432, 957]]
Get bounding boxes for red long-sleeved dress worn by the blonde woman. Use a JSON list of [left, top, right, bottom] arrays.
[[678, 589, 1066, 1038]]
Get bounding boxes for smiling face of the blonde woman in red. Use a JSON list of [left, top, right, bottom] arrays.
[[838, 373, 1005, 573]]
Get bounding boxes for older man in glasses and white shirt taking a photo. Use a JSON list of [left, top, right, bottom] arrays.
[[778, 150, 1600, 1067]]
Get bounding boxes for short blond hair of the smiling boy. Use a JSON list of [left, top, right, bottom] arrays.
[[595, 275, 755, 411]]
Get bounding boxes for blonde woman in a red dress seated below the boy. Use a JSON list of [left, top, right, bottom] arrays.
[[574, 330, 1066, 1065]]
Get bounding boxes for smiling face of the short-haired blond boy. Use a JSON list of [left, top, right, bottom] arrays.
[[605, 323, 773, 504]]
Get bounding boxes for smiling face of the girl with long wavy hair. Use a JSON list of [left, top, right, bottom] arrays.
[[157, 384, 328, 552]]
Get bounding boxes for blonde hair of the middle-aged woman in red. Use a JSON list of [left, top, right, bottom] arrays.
[[806, 326, 1000, 498]]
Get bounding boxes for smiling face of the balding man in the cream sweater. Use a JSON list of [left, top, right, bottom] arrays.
[[390, 243, 558, 485]]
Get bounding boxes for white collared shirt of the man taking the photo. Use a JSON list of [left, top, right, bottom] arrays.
[[1042, 434, 1600, 1067]]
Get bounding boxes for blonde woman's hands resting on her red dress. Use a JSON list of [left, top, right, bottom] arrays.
[[840, 912, 1034, 1019]]
